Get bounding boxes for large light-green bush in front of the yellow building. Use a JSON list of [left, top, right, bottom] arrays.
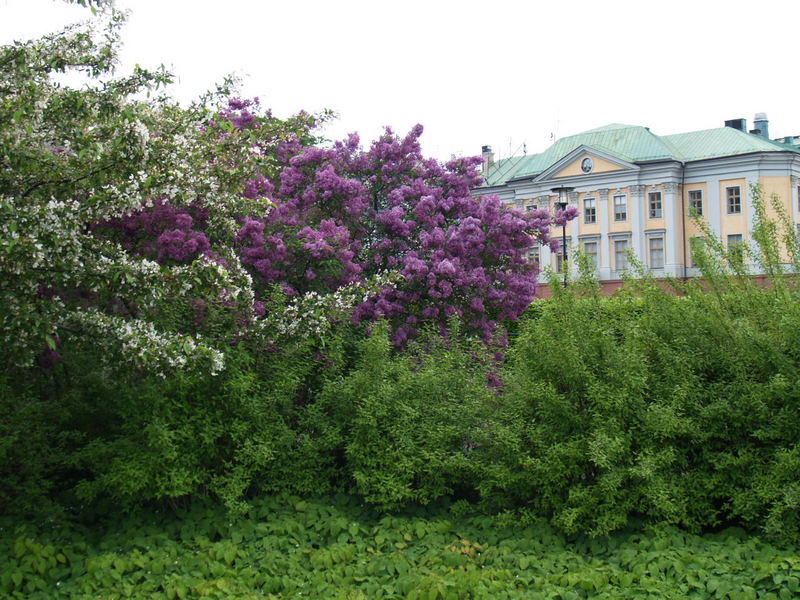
[[494, 190, 800, 539]]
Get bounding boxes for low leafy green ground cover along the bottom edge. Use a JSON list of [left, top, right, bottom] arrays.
[[0, 495, 800, 600]]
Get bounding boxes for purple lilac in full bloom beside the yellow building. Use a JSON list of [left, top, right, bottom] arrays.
[[235, 125, 577, 345]]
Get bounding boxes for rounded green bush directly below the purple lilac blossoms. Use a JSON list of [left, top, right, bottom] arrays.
[[317, 320, 501, 508]]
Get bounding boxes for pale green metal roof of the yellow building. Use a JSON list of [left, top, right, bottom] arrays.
[[484, 123, 800, 186]]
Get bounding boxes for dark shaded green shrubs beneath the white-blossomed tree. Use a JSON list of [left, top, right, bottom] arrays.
[[0, 324, 350, 514]]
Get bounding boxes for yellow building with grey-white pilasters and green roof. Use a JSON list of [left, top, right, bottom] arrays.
[[475, 113, 800, 284]]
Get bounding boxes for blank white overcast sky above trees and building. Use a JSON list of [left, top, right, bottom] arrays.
[[0, 0, 800, 159]]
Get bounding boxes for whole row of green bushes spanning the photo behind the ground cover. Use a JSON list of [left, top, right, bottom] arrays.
[[0, 207, 800, 541]]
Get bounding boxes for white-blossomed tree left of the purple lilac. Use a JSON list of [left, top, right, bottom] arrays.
[[0, 1, 359, 374]]
